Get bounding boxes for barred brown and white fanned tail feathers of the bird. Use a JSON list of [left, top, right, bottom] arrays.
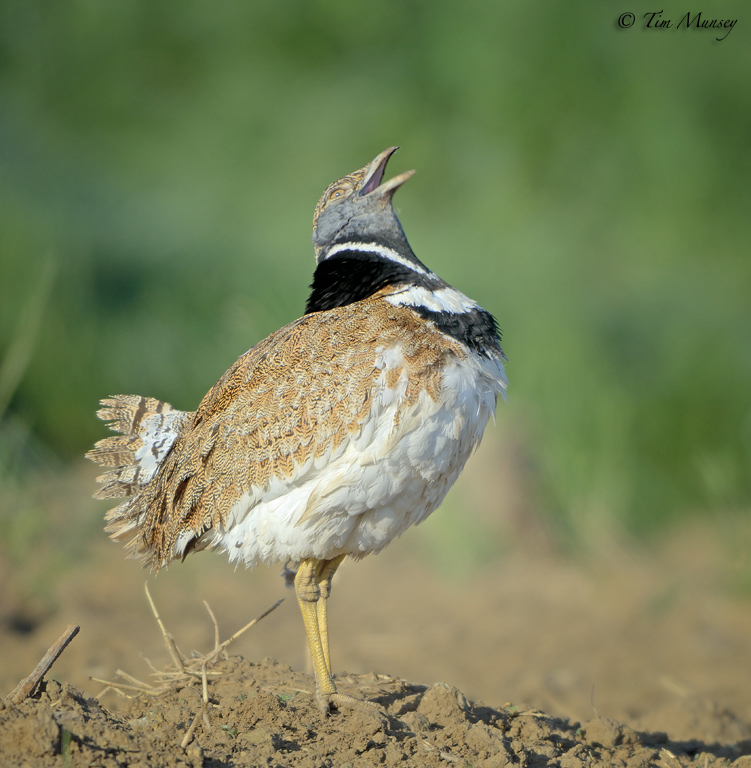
[[86, 395, 190, 500]]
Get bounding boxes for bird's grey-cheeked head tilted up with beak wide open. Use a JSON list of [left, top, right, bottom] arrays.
[[313, 147, 415, 263]]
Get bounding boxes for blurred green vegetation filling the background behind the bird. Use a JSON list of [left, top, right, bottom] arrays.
[[0, 0, 751, 556]]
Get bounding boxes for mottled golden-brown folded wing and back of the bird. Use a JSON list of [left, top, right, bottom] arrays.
[[108, 304, 383, 568]]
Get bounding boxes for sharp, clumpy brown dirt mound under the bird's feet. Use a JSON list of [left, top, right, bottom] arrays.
[[0, 656, 751, 768]]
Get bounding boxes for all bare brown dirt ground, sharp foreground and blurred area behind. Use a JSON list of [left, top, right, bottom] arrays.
[[0, 456, 751, 768]]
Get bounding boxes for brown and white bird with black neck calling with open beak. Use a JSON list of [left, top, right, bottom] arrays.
[[86, 147, 507, 714]]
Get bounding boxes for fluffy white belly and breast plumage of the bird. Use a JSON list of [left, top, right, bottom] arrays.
[[211, 349, 506, 566]]
